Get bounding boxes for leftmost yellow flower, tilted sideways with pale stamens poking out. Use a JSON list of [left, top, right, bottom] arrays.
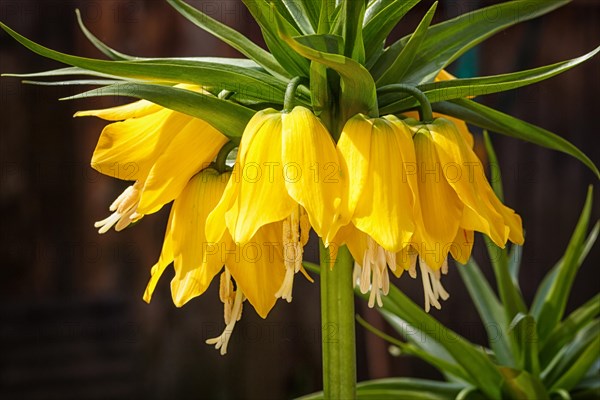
[[75, 85, 227, 233]]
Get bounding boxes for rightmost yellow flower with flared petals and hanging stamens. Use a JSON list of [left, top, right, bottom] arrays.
[[402, 118, 524, 308]]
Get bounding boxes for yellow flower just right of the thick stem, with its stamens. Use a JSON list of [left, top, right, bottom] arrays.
[[337, 114, 418, 307]]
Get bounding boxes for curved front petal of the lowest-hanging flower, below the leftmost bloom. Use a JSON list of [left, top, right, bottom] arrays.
[[171, 169, 233, 307]]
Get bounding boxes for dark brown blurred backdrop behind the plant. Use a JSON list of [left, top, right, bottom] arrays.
[[0, 0, 600, 399]]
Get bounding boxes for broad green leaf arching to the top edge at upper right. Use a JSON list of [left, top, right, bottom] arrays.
[[371, 0, 570, 85]]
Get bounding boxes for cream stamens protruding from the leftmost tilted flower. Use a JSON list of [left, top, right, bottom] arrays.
[[94, 181, 143, 234]]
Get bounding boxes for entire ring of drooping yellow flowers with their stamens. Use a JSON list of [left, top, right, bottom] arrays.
[[76, 73, 523, 354]]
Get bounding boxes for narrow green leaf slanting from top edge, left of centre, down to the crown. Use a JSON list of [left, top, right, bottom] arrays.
[[167, 0, 291, 78]]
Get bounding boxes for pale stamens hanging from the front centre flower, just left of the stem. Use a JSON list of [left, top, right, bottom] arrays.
[[275, 207, 308, 303]]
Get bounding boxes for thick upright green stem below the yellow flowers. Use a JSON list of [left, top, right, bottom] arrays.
[[320, 241, 356, 399]]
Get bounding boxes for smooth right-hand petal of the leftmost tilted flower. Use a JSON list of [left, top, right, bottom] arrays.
[[137, 118, 228, 219]]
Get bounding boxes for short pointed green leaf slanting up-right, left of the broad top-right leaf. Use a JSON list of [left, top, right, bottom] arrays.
[[376, 1, 438, 86]]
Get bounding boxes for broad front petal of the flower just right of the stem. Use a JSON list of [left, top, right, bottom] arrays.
[[349, 118, 416, 253]]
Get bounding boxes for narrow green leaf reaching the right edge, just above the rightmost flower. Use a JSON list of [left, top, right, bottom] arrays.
[[377, 46, 600, 110]]
